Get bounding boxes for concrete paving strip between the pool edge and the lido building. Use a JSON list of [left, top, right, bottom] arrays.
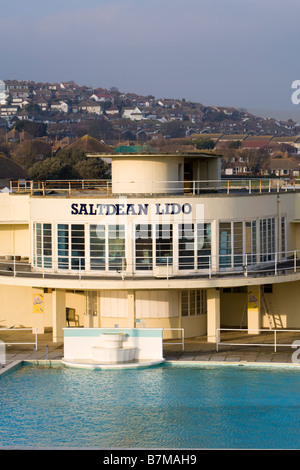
[[0, 329, 300, 371]]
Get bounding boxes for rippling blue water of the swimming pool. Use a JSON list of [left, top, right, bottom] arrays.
[[0, 365, 300, 449]]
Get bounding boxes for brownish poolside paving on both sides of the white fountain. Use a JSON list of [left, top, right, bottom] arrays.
[[0, 329, 300, 369]]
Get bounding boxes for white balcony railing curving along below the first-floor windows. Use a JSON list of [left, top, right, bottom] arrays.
[[0, 250, 300, 279]]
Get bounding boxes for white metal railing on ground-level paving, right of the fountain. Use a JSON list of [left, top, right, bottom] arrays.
[[216, 328, 300, 352]]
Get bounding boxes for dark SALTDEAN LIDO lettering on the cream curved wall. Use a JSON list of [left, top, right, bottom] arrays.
[[71, 202, 198, 216]]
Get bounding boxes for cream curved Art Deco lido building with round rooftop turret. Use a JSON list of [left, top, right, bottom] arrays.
[[0, 152, 300, 342]]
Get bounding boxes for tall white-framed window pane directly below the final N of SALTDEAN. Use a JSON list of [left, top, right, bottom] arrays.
[[135, 225, 153, 270]]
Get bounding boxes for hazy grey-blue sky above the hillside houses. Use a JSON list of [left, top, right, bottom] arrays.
[[0, 0, 300, 120]]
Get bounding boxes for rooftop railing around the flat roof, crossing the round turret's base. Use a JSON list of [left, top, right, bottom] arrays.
[[10, 177, 300, 196]]
